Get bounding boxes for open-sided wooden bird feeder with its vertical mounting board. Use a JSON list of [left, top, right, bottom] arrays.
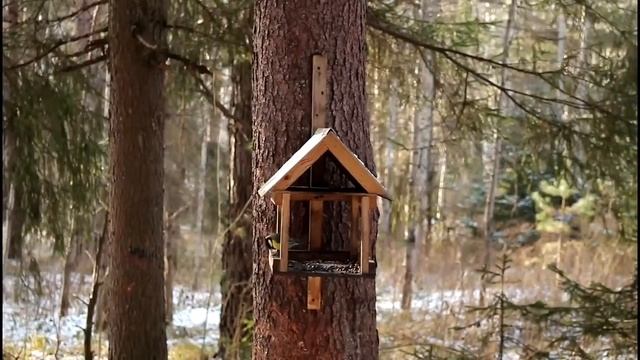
[[258, 55, 390, 310]]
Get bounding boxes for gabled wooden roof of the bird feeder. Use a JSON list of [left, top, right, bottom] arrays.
[[258, 128, 391, 200]]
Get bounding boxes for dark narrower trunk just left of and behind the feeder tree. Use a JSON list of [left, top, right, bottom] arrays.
[[219, 60, 253, 359]]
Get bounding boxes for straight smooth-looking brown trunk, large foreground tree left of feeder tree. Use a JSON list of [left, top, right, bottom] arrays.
[[108, 0, 167, 359]]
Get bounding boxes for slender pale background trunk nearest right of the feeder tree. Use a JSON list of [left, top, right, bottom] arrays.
[[401, 0, 440, 310]]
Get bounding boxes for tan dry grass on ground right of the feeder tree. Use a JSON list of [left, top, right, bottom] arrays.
[[377, 226, 637, 359]]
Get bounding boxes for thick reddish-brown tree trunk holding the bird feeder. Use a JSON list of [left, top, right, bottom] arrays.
[[253, 0, 378, 359]]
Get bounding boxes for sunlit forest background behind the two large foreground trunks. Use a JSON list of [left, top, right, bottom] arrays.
[[2, 0, 637, 359]]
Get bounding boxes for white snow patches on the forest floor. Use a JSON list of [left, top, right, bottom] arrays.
[[2, 273, 556, 358]]
